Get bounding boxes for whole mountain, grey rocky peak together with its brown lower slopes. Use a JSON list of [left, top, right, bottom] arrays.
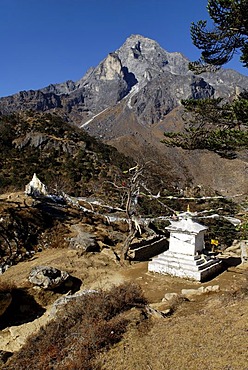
[[0, 35, 248, 197]]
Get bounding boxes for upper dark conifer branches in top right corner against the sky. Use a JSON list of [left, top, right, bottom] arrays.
[[189, 0, 248, 73]]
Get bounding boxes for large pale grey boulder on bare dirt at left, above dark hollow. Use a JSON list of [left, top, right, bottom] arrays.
[[28, 266, 70, 290]]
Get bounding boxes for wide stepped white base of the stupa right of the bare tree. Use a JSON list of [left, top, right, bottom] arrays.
[[148, 250, 221, 281]]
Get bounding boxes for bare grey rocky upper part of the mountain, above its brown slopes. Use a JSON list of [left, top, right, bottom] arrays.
[[0, 35, 248, 125]]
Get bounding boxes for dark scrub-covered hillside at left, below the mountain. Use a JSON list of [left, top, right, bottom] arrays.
[[0, 112, 131, 195]]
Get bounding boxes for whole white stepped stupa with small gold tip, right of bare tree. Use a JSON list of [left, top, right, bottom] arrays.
[[148, 216, 221, 281]]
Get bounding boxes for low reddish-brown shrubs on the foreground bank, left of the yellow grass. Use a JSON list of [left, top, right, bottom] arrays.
[[5, 284, 147, 370]]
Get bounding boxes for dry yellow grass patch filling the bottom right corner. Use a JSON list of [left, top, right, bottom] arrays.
[[98, 297, 248, 370]]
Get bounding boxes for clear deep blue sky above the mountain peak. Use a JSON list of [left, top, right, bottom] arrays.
[[0, 0, 247, 96]]
